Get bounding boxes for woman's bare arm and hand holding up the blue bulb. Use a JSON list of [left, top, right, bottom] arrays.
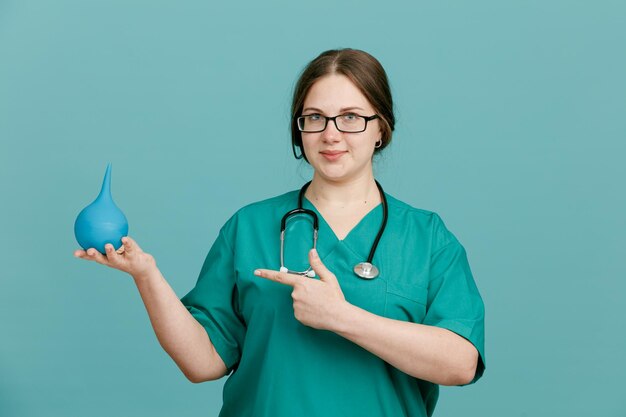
[[74, 237, 226, 382]]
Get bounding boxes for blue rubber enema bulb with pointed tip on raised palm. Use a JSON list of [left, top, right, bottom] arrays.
[[74, 163, 128, 254]]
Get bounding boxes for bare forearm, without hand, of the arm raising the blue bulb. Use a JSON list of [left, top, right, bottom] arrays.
[[133, 267, 226, 382]]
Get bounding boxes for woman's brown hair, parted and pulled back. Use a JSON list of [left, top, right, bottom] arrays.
[[291, 49, 396, 162]]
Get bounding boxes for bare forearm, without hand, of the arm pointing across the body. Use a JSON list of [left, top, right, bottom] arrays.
[[333, 303, 478, 385]]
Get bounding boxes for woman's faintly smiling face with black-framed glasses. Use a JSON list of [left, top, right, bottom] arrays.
[[302, 74, 381, 182]]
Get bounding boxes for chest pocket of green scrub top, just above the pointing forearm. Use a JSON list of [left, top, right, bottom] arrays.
[[385, 282, 428, 323]]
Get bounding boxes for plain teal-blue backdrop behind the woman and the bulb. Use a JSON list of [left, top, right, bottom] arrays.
[[0, 0, 626, 417]]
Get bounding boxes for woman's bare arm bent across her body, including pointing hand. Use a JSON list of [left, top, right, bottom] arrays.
[[255, 250, 478, 385]]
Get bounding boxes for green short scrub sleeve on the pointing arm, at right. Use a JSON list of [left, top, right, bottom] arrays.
[[424, 214, 485, 384]]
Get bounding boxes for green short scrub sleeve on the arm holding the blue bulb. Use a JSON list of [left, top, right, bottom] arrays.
[[181, 229, 246, 372]]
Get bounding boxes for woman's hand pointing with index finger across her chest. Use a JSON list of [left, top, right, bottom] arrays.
[[254, 249, 348, 331]]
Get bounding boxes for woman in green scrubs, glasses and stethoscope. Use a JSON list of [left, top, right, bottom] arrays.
[[75, 49, 484, 417]]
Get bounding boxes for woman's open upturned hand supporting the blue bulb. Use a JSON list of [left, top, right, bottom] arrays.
[[74, 236, 156, 279]]
